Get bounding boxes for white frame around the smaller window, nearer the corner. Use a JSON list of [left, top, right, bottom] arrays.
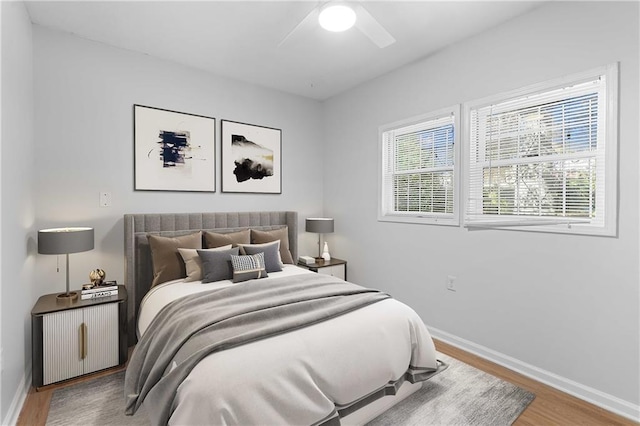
[[378, 105, 461, 226]]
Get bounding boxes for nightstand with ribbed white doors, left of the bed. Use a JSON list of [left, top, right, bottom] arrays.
[[31, 285, 127, 388]]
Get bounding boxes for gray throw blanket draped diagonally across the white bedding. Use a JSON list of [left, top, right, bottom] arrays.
[[125, 274, 390, 425]]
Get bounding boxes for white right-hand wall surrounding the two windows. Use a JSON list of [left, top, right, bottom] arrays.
[[324, 2, 640, 417]]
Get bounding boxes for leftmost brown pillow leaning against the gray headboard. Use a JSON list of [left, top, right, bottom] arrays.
[[147, 231, 202, 287]]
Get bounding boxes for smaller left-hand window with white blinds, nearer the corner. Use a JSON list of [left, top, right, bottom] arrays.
[[378, 106, 460, 225]]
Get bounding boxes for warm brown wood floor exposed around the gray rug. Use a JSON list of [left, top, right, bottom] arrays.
[[17, 340, 638, 426]]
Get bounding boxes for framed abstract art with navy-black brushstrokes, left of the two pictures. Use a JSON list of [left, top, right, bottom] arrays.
[[133, 104, 216, 192]]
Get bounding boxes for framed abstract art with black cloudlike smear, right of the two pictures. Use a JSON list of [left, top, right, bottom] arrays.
[[221, 120, 282, 194]]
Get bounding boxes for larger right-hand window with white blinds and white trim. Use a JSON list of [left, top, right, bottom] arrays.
[[464, 64, 618, 235]]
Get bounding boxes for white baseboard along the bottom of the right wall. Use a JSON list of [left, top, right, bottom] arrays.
[[427, 327, 640, 422]]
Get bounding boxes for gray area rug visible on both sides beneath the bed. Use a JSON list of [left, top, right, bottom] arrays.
[[47, 354, 535, 426]]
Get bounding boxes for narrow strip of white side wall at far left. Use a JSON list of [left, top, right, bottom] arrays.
[[0, 2, 35, 424]]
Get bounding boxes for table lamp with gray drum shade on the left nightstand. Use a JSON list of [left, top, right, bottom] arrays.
[[38, 227, 93, 301]]
